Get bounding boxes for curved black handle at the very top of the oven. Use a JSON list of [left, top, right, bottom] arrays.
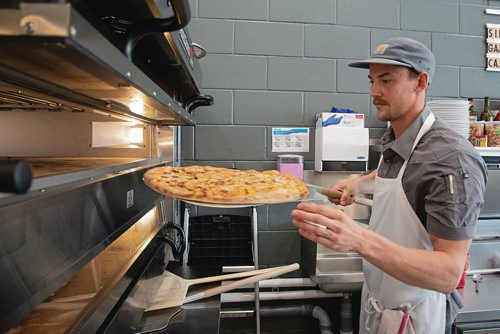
[[123, 0, 191, 60]]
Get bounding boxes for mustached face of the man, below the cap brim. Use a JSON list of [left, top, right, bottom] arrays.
[[368, 64, 418, 121]]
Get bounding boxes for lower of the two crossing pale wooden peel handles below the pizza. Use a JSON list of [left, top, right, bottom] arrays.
[[184, 263, 300, 303]]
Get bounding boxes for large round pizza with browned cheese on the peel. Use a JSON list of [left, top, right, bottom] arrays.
[[143, 166, 308, 204]]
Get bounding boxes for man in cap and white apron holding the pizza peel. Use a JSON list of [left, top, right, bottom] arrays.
[[292, 38, 487, 334]]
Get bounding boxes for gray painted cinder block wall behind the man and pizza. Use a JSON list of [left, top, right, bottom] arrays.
[[181, 0, 500, 265]]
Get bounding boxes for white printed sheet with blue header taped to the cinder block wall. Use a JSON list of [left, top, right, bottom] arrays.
[[272, 128, 309, 152]]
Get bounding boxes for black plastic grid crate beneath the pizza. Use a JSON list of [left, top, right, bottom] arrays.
[[188, 215, 253, 266]]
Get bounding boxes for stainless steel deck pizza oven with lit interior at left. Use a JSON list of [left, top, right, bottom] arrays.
[[0, 0, 213, 333]]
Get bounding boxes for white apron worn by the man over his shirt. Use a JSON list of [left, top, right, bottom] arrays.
[[359, 113, 446, 334]]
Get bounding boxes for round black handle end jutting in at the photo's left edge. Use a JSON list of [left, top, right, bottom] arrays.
[[0, 159, 32, 194]]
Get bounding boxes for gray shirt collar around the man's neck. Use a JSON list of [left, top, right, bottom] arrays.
[[382, 105, 431, 160]]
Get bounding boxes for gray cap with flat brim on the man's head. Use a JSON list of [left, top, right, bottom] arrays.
[[349, 37, 436, 82]]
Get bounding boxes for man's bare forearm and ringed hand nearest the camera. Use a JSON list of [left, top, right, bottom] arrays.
[[291, 203, 471, 294]]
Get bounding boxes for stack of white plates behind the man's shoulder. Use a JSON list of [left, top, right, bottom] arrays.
[[427, 100, 469, 138]]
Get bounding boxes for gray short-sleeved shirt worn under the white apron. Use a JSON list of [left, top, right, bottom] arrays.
[[378, 106, 487, 326]]
